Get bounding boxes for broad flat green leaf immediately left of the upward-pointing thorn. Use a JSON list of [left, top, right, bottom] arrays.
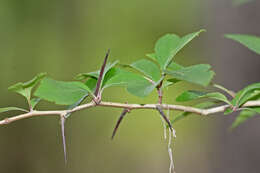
[[35, 78, 93, 105]]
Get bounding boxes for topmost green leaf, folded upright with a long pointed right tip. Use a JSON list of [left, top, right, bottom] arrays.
[[154, 30, 205, 70]]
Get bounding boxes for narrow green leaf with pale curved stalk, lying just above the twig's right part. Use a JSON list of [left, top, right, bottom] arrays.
[[176, 91, 231, 105]]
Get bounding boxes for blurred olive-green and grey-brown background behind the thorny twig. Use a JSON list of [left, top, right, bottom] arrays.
[[0, 0, 260, 173]]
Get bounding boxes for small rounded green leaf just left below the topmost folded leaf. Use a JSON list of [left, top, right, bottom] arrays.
[[130, 59, 161, 82]]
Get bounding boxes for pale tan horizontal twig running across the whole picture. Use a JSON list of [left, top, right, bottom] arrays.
[[0, 100, 260, 125]]
